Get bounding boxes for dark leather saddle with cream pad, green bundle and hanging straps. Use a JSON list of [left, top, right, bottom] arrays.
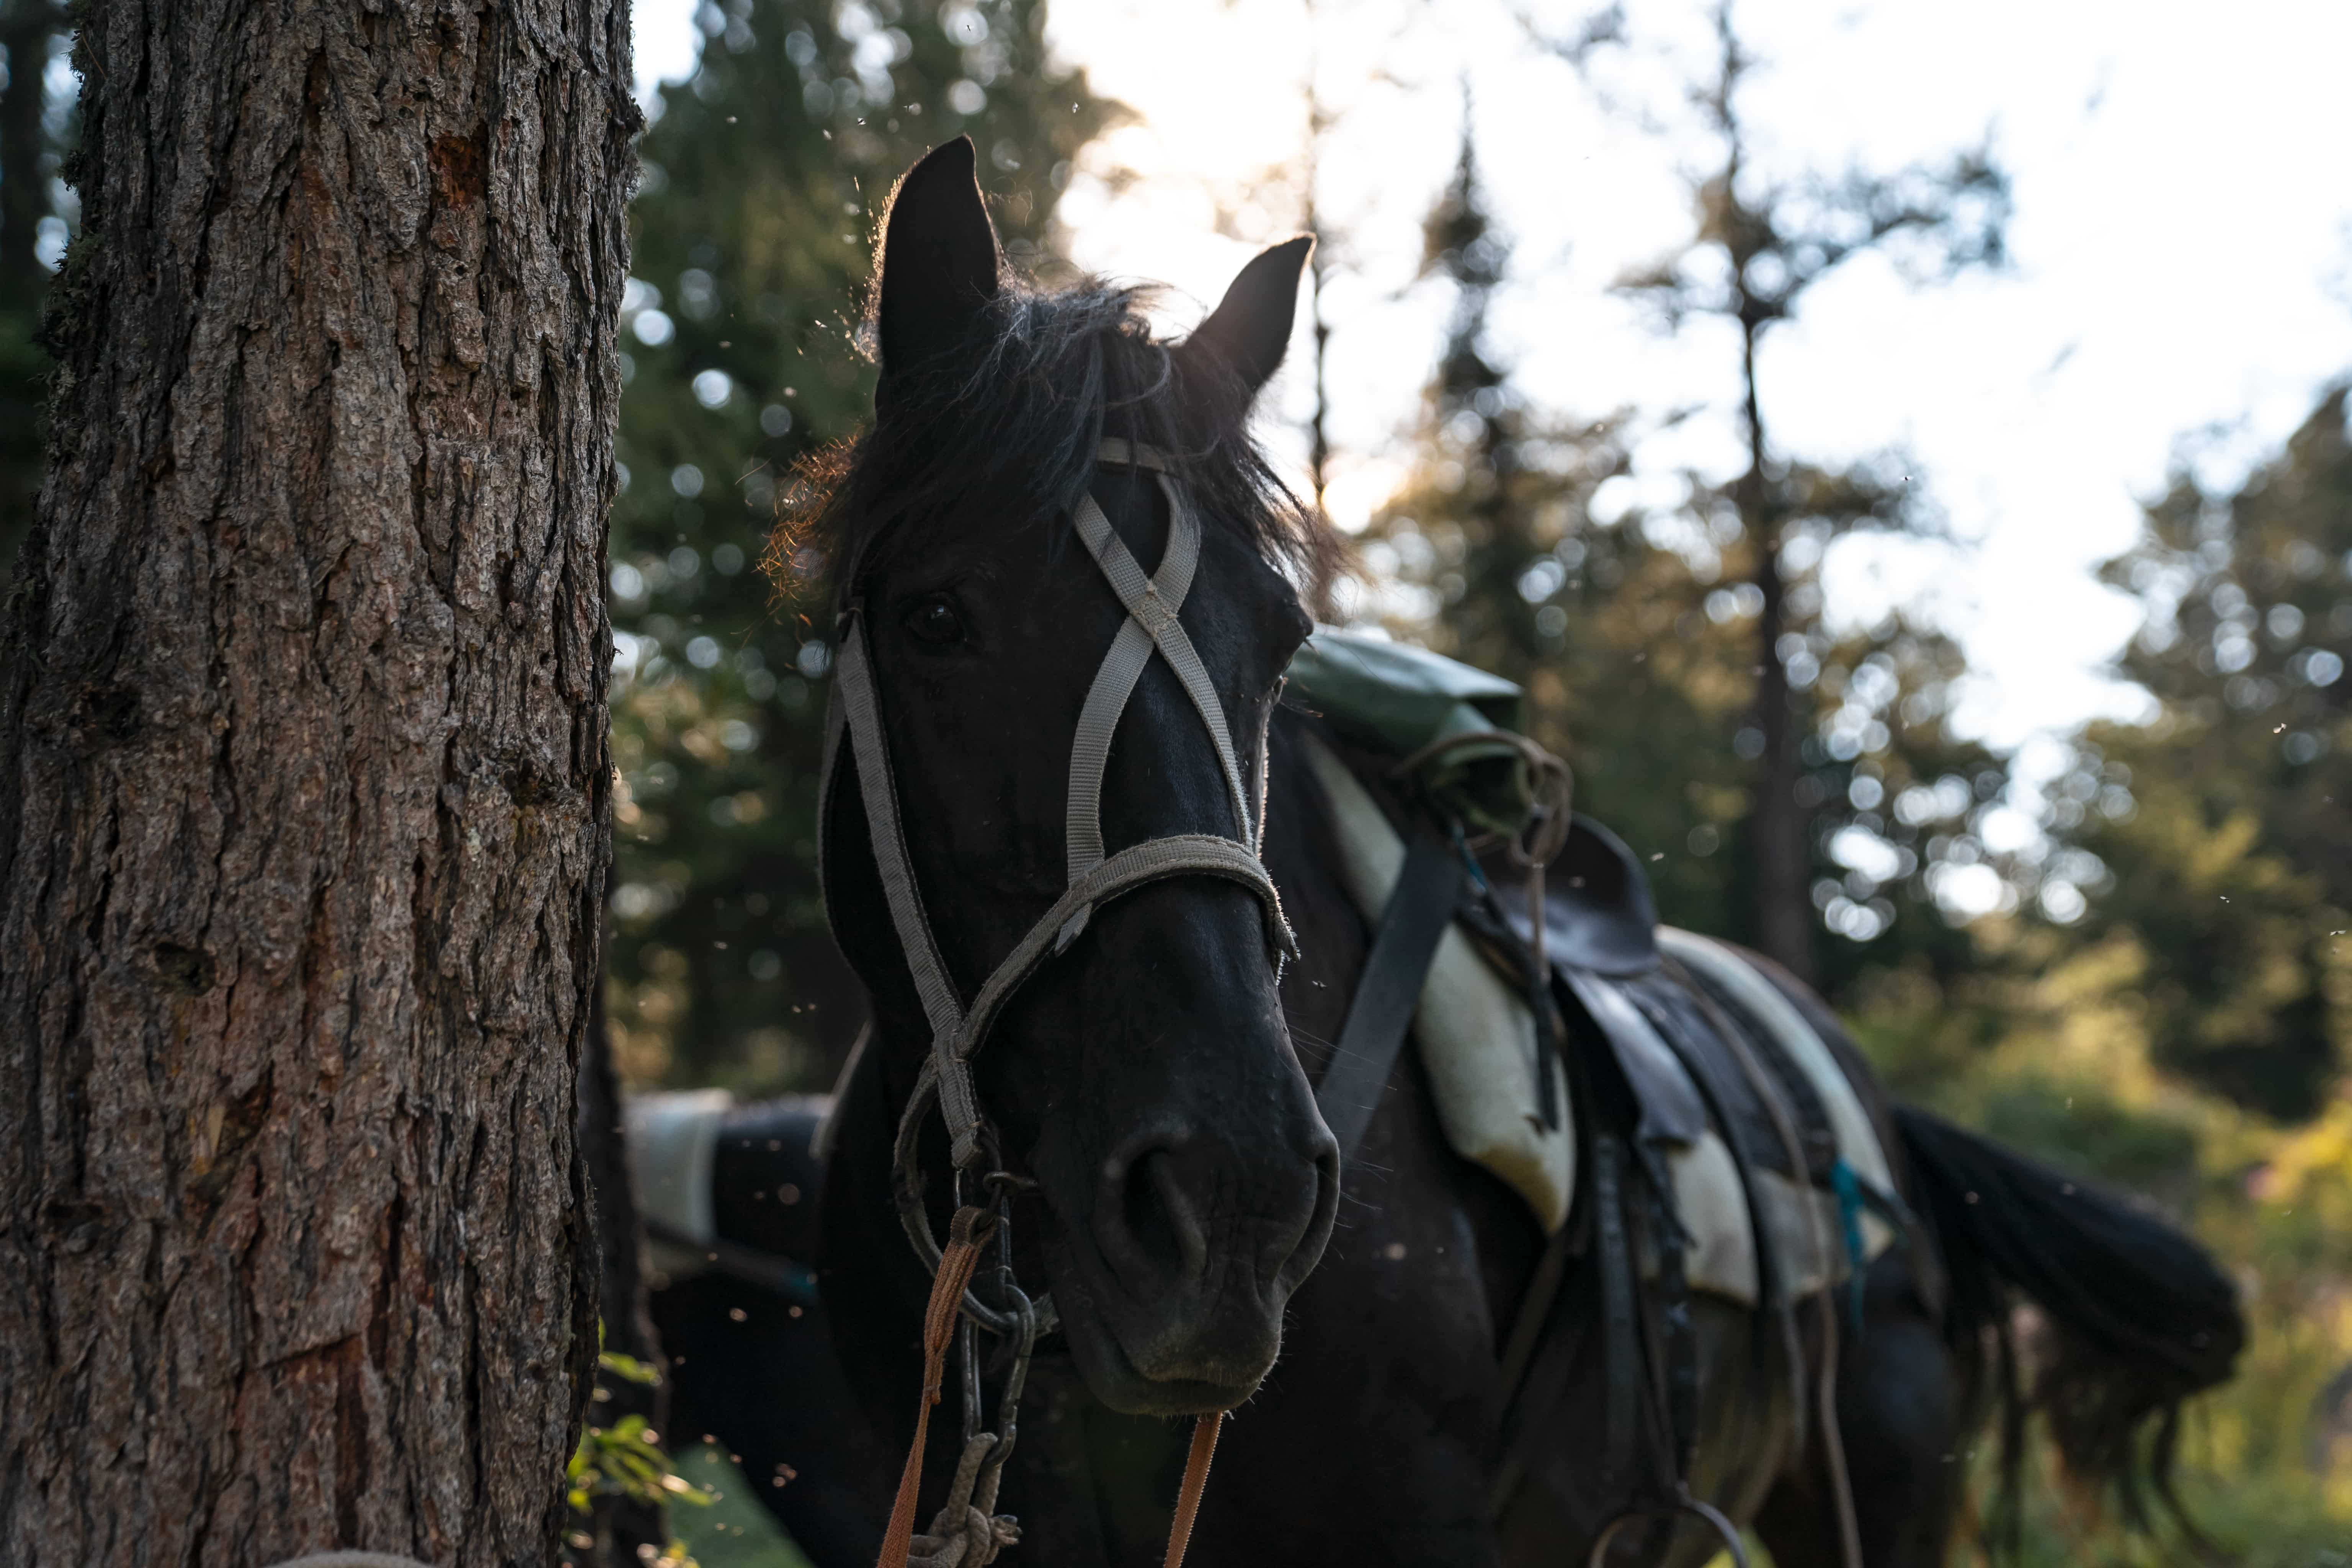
[[1291, 630, 1908, 1561]]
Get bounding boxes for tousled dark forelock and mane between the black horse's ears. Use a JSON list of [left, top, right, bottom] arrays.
[[762, 278, 1345, 609]]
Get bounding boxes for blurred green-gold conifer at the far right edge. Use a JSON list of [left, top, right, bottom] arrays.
[[2051, 388, 2352, 1117]]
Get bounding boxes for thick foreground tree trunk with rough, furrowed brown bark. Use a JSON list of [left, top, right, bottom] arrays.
[[0, 0, 637, 1568]]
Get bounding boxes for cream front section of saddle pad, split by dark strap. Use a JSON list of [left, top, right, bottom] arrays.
[[1305, 736, 1576, 1234]]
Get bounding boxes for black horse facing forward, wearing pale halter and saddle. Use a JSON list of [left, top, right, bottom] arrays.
[[673, 141, 2241, 1568]]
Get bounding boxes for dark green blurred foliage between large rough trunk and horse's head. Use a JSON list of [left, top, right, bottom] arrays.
[[607, 0, 1117, 1093]]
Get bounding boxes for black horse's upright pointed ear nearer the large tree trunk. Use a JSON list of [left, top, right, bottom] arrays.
[[875, 136, 997, 376]]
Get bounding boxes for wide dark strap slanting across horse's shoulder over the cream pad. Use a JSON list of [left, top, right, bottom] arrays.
[[1315, 830, 1463, 1166]]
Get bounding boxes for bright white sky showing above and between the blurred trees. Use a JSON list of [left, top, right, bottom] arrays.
[[637, 0, 2352, 761]]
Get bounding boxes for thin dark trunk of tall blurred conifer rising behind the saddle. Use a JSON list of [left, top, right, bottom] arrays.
[[1733, 324, 1813, 983]]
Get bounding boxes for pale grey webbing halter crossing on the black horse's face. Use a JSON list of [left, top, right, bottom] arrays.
[[818, 439, 1296, 1213]]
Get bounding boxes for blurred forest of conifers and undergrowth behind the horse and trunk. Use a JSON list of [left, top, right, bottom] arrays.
[[0, 0, 2352, 1568]]
